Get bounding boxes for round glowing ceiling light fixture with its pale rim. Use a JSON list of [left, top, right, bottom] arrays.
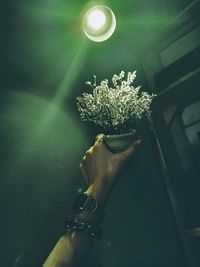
[[83, 6, 116, 42]]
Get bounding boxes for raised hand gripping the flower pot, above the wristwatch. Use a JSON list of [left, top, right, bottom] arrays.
[[80, 135, 141, 205]]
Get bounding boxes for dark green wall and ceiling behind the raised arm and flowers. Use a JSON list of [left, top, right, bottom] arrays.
[[0, 0, 200, 267]]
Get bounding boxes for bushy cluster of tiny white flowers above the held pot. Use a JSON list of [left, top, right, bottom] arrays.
[[77, 71, 155, 133]]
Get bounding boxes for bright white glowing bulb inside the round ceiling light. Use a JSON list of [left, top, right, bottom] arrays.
[[88, 9, 106, 30]]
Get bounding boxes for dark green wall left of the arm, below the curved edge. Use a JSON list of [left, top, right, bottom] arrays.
[[0, 90, 89, 266]]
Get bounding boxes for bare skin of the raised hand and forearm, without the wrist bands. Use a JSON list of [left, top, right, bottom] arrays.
[[43, 135, 141, 267]]
